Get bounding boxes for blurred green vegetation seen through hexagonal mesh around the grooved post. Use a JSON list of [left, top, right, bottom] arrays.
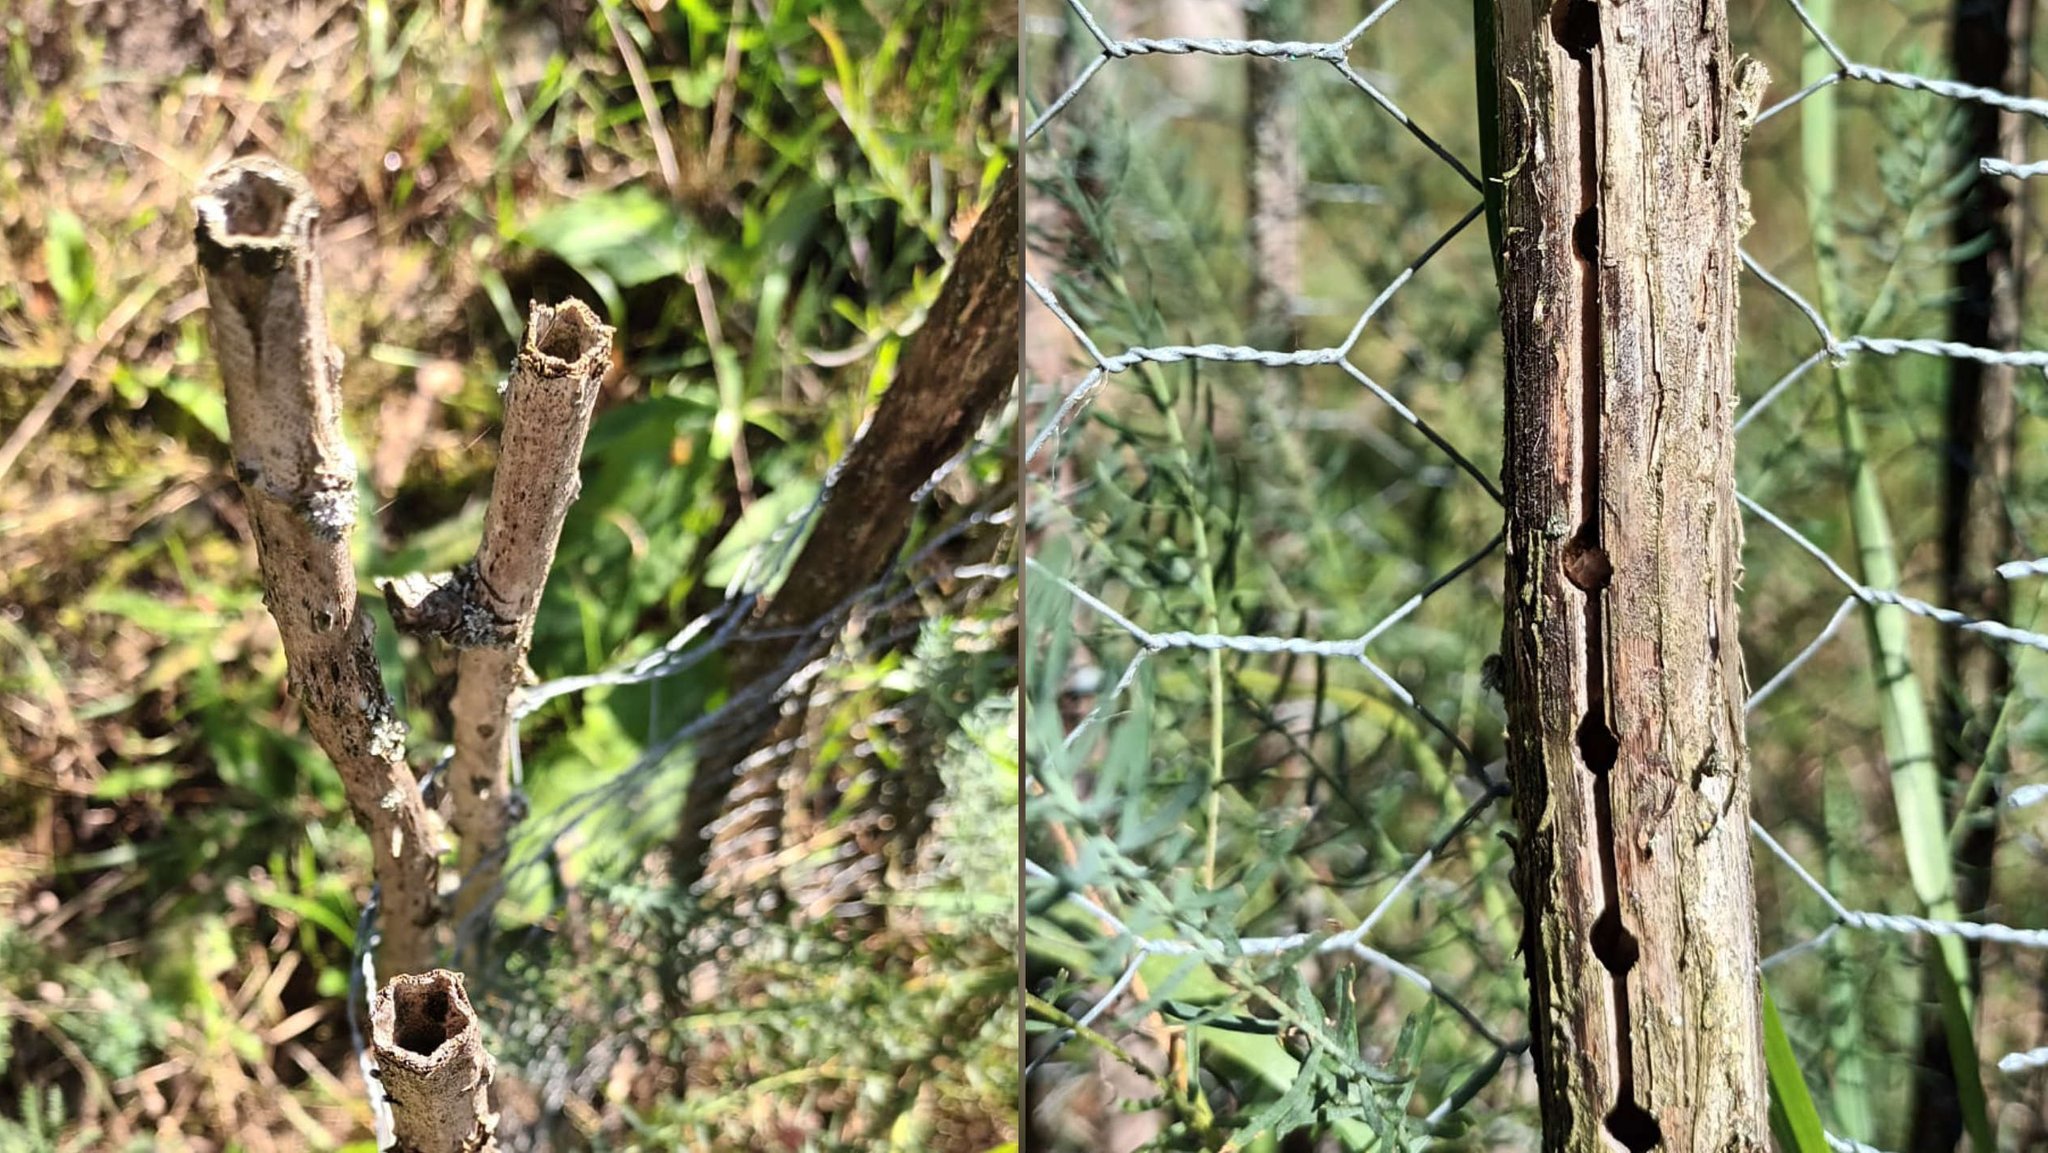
[[1024, 0, 2048, 1149]]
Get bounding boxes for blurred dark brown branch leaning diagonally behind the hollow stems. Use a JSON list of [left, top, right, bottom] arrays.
[[672, 170, 1022, 889]]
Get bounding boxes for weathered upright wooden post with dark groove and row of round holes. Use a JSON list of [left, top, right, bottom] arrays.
[[1493, 0, 1769, 1153]]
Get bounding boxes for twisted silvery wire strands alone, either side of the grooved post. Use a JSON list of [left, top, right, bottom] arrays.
[[1026, 0, 2048, 1153]]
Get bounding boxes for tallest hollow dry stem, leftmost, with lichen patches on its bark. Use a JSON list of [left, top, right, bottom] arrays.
[[193, 158, 438, 973]]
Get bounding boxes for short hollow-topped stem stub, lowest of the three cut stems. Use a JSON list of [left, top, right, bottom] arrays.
[[371, 969, 498, 1153]]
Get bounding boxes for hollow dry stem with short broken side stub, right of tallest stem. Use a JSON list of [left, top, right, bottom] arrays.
[[385, 301, 612, 930]]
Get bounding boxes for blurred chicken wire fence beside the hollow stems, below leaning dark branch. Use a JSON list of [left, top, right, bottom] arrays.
[[348, 395, 1016, 1151]]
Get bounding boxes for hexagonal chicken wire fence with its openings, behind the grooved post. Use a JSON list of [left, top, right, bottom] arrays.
[[1024, 0, 2048, 1149]]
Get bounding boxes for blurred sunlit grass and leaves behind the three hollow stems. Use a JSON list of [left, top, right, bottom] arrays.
[[0, 0, 1016, 1151]]
